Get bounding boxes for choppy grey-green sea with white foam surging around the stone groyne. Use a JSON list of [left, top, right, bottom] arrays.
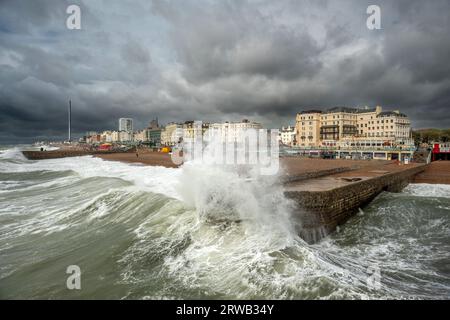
[[0, 148, 450, 299]]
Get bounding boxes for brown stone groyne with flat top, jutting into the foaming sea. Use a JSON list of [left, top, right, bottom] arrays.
[[285, 164, 427, 243]]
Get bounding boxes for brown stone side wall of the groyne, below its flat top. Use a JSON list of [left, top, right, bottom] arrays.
[[285, 165, 426, 243]]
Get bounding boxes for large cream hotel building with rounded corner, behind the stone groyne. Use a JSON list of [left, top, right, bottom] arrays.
[[295, 106, 414, 158]]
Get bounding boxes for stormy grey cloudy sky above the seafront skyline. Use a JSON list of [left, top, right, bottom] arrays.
[[0, 0, 450, 143]]
